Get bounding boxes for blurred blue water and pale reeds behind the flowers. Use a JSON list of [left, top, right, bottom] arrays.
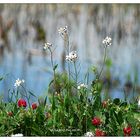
[[0, 4, 140, 101]]
